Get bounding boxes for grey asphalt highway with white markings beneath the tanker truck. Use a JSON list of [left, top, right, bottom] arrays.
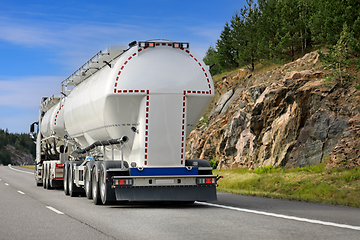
[[0, 166, 360, 240]]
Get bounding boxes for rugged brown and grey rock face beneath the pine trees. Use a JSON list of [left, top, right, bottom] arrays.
[[186, 52, 360, 169]]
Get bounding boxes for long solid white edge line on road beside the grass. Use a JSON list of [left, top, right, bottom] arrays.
[[196, 202, 360, 231]]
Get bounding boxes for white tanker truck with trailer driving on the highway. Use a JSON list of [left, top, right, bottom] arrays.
[[31, 40, 218, 204]]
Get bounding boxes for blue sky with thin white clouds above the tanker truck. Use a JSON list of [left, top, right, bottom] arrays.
[[0, 0, 245, 133]]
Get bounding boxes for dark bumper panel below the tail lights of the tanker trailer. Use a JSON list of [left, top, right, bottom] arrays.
[[115, 185, 217, 201]]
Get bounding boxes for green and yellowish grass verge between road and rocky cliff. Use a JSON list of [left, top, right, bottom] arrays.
[[214, 164, 360, 207]]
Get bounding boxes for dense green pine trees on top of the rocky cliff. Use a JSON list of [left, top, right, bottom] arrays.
[[204, 0, 360, 82]]
